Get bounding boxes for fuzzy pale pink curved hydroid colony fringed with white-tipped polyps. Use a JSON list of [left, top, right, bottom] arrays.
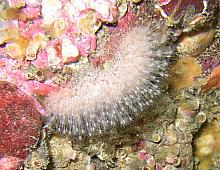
[[46, 26, 169, 137]]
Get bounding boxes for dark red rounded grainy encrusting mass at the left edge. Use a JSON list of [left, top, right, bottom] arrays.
[[0, 82, 42, 170]]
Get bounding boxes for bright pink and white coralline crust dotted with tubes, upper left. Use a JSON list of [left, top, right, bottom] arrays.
[[0, 0, 128, 96]]
